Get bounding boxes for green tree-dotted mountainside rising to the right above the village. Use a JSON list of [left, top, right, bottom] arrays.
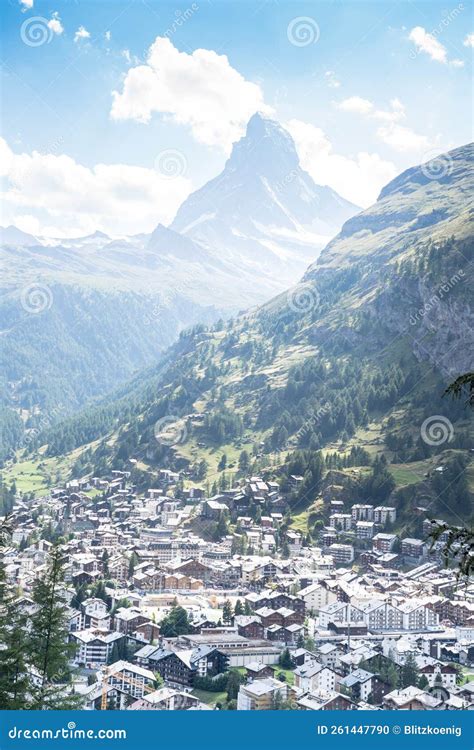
[[39, 145, 474, 522]]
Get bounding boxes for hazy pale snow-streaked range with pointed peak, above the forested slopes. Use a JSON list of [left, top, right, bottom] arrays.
[[0, 114, 358, 312]]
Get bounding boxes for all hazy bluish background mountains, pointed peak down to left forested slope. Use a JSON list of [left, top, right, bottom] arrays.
[[0, 116, 356, 440]]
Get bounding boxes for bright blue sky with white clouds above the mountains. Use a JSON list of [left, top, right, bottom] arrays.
[[0, 0, 473, 235]]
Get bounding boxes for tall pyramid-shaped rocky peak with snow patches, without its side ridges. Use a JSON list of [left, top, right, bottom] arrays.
[[171, 114, 358, 280]]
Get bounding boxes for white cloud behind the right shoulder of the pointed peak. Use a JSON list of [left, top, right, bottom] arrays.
[[286, 120, 398, 208]]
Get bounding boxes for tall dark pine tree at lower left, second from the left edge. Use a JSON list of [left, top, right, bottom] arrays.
[[30, 546, 79, 710]]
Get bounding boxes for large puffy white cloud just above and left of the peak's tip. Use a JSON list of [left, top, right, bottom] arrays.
[[111, 37, 270, 153]]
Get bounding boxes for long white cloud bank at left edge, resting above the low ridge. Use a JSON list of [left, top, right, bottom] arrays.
[[0, 138, 191, 236]]
